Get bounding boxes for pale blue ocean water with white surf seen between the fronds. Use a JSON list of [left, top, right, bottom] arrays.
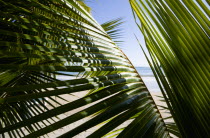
[[56, 67, 160, 92]]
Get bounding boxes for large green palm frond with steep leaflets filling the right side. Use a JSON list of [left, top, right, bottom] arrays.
[[130, 0, 210, 137]]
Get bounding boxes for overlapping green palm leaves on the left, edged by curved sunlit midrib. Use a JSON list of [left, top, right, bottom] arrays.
[[0, 0, 169, 137]]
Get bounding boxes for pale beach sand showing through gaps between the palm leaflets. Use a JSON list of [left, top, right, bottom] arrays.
[[3, 91, 173, 138]]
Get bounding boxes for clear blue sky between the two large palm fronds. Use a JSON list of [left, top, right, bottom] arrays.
[[86, 0, 149, 67]]
